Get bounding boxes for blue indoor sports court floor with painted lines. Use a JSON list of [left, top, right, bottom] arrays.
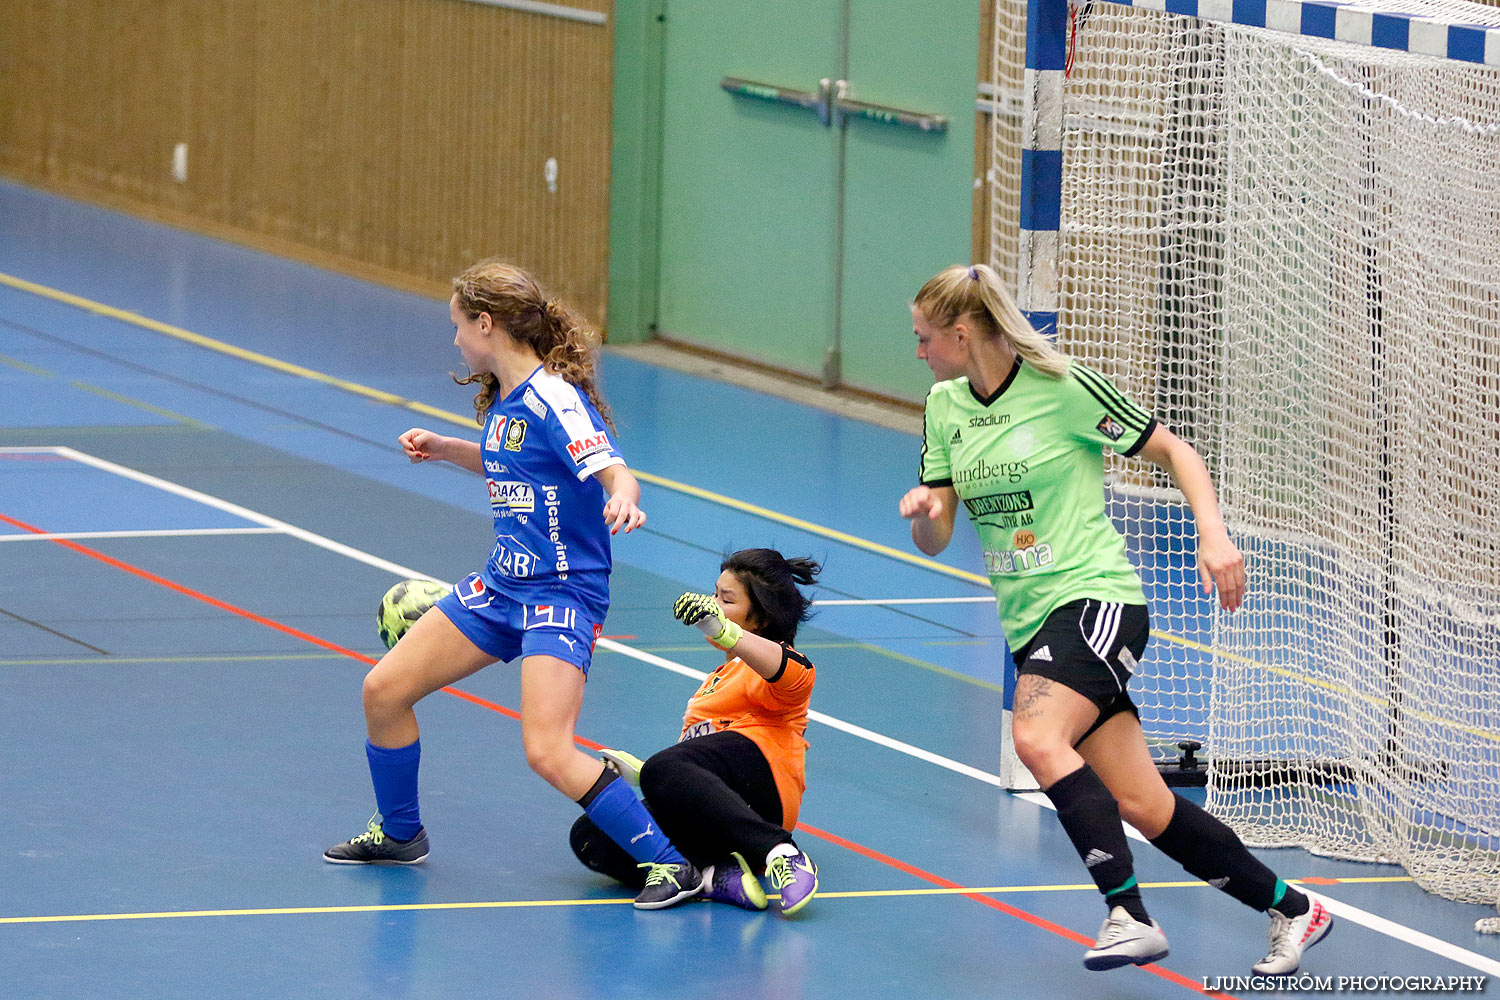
[[0, 176, 1500, 1000]]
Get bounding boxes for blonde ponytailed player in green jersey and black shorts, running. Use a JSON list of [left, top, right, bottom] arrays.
[[900, 264, 1332, 976]]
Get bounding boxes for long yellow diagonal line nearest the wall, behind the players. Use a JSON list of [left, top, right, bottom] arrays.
[[0, 271, 990, 588]]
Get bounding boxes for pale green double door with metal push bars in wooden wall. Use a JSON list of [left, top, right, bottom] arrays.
[[656, 0, 978, 399]]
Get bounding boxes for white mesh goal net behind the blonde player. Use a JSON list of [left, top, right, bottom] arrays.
[[995, 0, 1500, 903]]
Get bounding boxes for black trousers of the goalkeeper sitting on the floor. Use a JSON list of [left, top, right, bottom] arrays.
[[569, 732, 792, 889]]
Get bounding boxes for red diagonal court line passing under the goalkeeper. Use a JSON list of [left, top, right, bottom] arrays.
[[11, 514, 1230, 997]]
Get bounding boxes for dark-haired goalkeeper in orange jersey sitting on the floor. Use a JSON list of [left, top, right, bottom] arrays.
[[570, 549, 819, 916]]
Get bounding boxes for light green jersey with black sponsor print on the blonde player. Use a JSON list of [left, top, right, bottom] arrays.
[[921, 360, 1157, 649]]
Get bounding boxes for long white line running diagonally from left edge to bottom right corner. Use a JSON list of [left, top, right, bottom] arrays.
[[0, 447, 1500, 976]]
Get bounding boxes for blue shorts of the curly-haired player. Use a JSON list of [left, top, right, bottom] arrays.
[[434, 573, 605, 675]]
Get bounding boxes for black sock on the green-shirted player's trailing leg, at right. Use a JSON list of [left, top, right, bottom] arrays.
[[1151, 795, 1308, 916]]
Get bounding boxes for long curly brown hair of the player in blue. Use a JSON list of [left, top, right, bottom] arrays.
[[453, 259, 615, 430]]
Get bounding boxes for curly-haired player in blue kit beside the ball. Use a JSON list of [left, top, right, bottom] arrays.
[[323, 261, 702, 909]]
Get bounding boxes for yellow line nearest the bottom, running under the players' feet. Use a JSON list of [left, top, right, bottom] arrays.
[[0, 876, 1412, 924]]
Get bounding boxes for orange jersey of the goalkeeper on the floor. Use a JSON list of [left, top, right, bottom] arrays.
[[678, 643, 818, 829]]
